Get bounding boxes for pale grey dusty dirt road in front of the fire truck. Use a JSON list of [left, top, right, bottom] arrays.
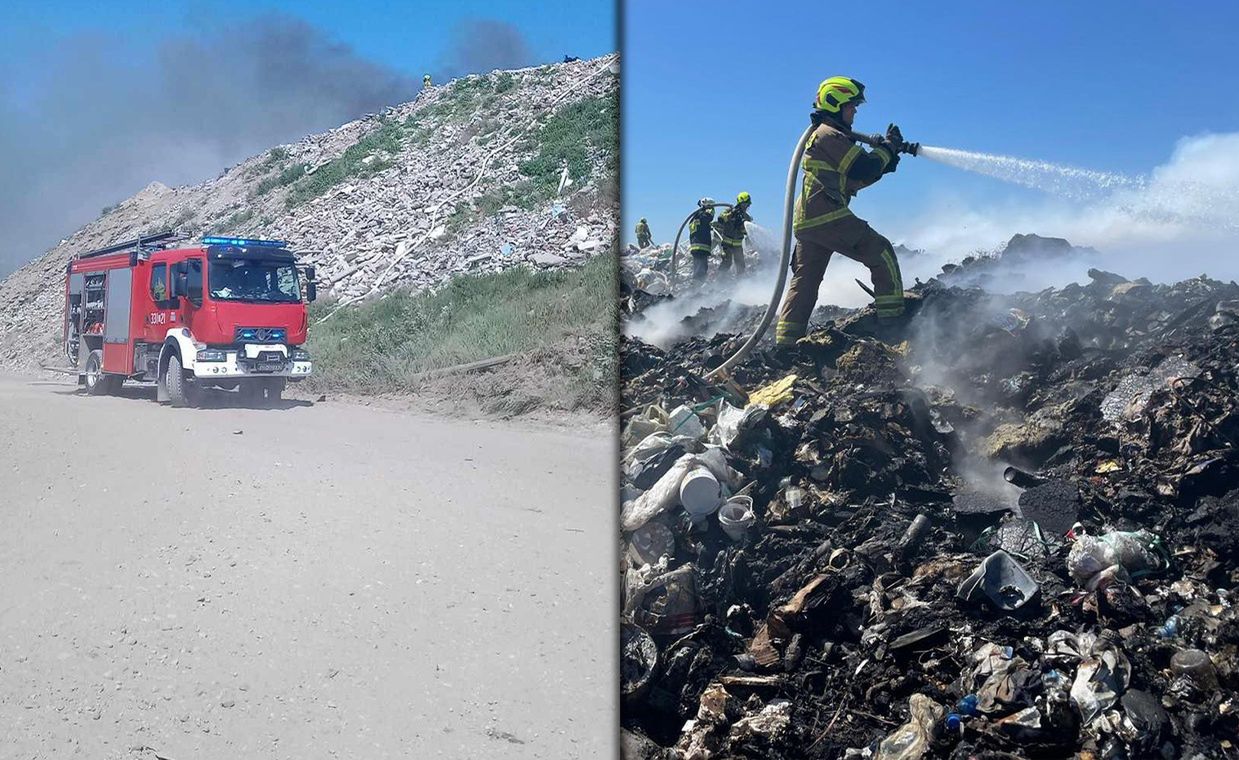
[[0, 379, 618, 760]]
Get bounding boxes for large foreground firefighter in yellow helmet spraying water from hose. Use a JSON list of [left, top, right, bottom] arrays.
[[774, 77, 903, 346]]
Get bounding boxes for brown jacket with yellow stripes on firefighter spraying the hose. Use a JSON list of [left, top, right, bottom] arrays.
[[793, 115, 898, 229]]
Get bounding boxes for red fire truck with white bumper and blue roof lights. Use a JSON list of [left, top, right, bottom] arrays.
[[64, 232, 317, 407]]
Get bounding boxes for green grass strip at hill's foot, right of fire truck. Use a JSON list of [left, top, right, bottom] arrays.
[[307, 255, 616, 408]]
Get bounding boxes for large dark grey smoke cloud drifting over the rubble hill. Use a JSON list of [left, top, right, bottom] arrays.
[[0, 15, 420, 276]]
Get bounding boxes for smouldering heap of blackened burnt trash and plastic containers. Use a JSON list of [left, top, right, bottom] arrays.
[[620, 272, 1239, 759]]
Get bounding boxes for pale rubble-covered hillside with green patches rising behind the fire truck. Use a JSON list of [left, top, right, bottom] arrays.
[[0, 55, 618, 372]]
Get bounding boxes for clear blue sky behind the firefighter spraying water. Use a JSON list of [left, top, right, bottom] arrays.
[[623, 0, 1239, 251]]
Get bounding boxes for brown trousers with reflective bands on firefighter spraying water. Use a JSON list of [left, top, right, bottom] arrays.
[[774, 213, 903, 345]]
